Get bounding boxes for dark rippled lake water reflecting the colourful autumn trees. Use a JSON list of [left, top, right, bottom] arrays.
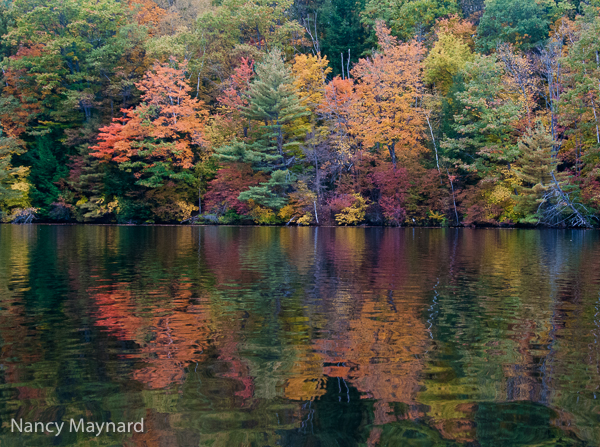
[[0, 225, 600, 447]]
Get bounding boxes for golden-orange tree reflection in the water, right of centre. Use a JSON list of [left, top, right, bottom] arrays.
[[315, 297, 427, 424]]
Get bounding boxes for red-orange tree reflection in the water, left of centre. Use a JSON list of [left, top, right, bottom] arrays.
[[90, 282, 210, 388]]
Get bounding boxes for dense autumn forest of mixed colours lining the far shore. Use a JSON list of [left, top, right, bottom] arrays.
[[0, 0, 600, 228]]
